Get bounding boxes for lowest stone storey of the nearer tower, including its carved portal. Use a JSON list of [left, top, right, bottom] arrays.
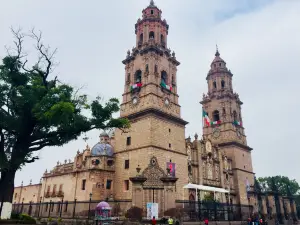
[[114, 147, 188, 215]]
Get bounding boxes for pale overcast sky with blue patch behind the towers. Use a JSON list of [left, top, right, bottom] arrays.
[[0, 0, 300, 185]]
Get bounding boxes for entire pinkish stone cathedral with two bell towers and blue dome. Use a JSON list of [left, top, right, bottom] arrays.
[[13, 1, 264, 218]]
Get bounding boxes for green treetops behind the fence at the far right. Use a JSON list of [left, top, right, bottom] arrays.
[[258, 176, 300, 196]]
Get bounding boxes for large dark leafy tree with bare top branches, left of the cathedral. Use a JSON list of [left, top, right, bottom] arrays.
[[0, 29, 129, 218]]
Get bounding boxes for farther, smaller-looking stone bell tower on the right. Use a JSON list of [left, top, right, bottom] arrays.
[[200, 49, 254, 204]]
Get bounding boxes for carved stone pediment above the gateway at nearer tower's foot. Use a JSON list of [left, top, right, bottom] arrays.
[[142, 156, 166, 188]]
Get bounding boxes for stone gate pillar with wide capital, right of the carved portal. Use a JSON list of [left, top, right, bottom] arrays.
[[160, 176, 178, 211]]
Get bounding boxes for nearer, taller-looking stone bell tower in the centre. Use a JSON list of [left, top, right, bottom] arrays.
[[114, 1, 188, 203]]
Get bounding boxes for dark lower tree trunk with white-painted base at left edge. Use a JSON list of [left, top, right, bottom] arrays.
[[0, 170, 16, 219]]
